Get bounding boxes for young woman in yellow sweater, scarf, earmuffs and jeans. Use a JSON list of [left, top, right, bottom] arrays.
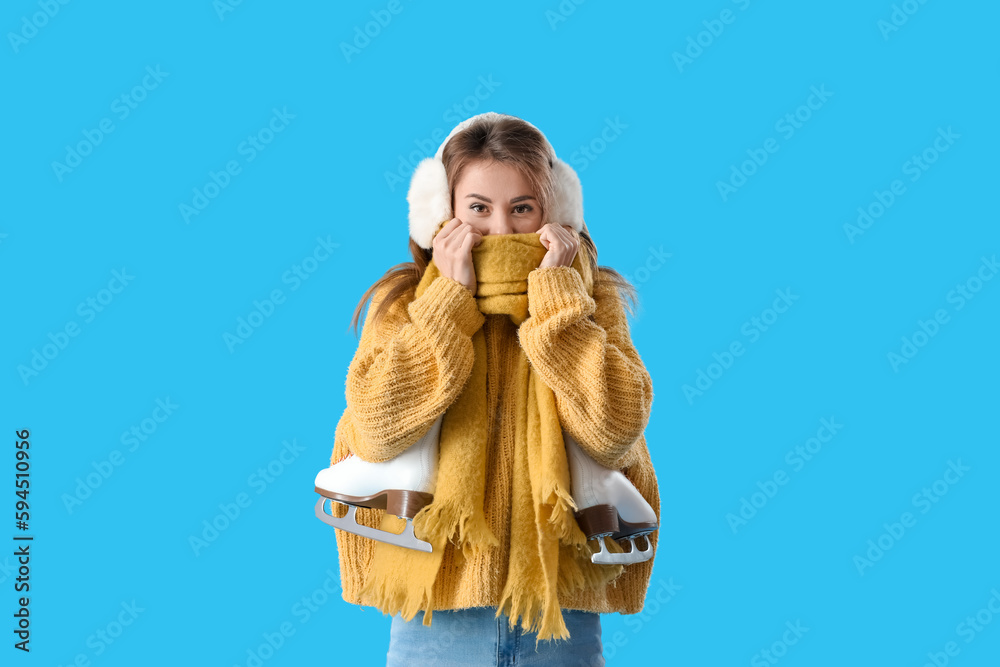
[[317, 112, 659, 666]]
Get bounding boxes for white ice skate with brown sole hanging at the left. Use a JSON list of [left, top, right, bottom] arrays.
[[316, 415, 444, 552]]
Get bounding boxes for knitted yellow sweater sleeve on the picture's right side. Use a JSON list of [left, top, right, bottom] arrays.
[[518, 266, 653, 468]]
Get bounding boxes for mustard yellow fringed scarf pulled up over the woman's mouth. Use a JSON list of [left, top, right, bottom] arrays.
[[361, 228, 622, 641]]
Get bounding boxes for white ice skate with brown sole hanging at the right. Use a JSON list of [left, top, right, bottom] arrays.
[[563, 430, 659, 565]]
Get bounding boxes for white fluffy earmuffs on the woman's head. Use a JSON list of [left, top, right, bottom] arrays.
[[406, 111, 584, 249]]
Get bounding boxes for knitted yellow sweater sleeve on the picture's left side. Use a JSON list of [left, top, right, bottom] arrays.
[[340, 276, 485, 462]]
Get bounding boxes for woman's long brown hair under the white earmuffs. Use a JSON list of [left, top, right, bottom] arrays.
[[351, 116, 638, 336]]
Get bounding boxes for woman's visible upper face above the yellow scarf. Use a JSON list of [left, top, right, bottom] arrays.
[[455, 160, 542, 236]]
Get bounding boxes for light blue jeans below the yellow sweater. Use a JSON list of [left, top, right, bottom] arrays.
[[386, 607, 604, 667]]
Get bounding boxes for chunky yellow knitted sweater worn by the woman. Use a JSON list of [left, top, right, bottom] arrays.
[[330, 266, 660, 614]]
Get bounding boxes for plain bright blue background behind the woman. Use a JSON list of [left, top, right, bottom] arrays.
[[0, 0, 1000, 667]]
